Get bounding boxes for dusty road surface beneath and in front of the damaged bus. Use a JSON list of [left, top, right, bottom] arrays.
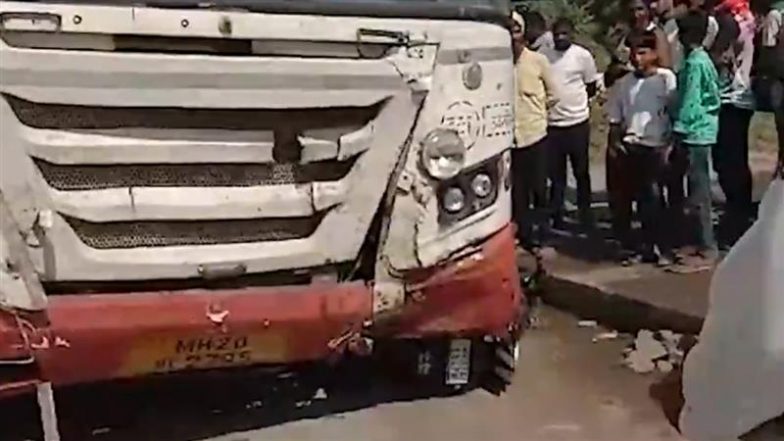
[[0, 309, 681, 441]]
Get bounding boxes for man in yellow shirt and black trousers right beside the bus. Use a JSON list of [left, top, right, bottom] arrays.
[[512, 12, 558, 254]]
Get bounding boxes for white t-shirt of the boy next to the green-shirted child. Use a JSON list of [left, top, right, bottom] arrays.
[[607, 68, 677, 147]]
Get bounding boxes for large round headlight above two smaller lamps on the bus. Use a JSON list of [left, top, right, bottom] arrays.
[[422, 128, 466, 180]]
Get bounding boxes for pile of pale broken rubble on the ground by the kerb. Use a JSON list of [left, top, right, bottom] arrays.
[[624, 329, 693, 374]]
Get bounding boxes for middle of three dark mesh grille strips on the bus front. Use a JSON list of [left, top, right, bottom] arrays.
[[35, 159, 354, 191]]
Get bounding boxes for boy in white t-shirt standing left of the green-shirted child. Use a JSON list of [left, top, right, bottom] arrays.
[[607, 30, 677, 265]]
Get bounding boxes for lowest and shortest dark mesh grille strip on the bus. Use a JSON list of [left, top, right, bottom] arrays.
[[65, 214, 323, 249]]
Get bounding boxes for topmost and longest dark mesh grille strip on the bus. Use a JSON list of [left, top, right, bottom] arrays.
[[4, 95, 380, 131]]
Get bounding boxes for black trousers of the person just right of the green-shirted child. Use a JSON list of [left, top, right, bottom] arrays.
[[712, 104, 754, 242]]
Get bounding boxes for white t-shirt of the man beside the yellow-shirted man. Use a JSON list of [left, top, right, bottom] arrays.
[[542, 44, 598, 127]]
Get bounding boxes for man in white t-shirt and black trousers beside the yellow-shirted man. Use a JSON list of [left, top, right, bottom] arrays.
[[543, 18, 598, 231]]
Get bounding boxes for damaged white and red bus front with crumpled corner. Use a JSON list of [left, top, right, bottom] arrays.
[[0, 0, 525, 394]]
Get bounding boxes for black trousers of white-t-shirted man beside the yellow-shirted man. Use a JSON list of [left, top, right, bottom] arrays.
[[547, 121, 593, 224]]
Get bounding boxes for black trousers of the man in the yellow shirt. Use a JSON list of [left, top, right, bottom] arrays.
[[512, 138, 549, 249]]
